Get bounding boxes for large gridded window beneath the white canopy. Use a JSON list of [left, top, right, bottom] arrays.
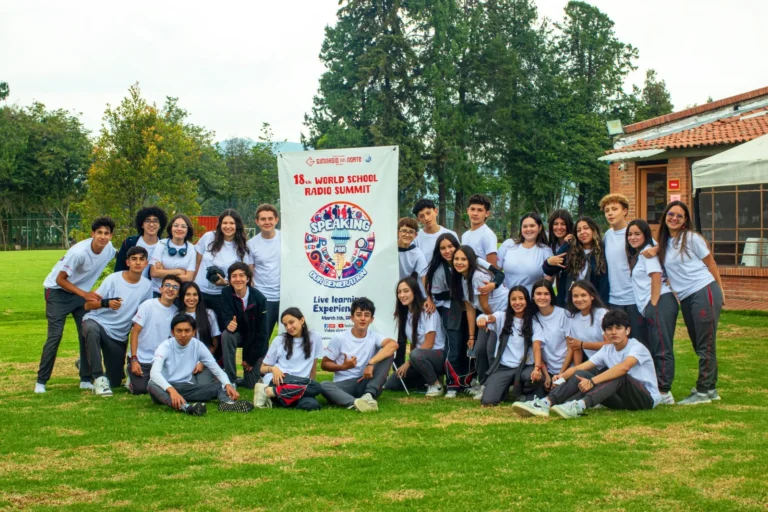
[[699, 184, 768, 268]]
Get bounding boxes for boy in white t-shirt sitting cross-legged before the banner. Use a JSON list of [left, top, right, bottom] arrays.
[[321, 297, 397, 412]]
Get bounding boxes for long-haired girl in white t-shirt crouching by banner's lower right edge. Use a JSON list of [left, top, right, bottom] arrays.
[[384, 276, 445, 397]]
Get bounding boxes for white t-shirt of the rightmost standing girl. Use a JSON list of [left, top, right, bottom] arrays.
[[664, 233, 715, 300]]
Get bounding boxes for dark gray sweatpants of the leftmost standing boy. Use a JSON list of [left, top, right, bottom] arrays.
[[37, 288, 91, 384]]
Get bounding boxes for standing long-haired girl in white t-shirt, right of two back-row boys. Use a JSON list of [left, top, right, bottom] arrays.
[[498, 212, 552, 293]]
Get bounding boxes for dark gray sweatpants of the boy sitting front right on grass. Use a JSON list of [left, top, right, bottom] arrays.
[[549, 370, 653, 411]]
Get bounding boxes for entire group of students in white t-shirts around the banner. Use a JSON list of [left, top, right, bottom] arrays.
[[35, 194, 723, 417]]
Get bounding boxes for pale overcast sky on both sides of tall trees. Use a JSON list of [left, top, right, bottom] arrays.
[[0, 0, 768, 141]]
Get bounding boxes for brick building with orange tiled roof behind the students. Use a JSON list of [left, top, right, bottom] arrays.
[[600, 87, 768, 309]]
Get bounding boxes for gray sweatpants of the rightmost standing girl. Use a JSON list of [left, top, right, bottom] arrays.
[[680, 281, 723, 393]]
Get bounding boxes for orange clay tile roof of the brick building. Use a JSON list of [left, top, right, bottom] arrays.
[[607, 107, 768, 154]]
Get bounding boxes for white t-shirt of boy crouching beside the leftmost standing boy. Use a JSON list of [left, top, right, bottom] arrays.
[[83, 272, 152, 341]]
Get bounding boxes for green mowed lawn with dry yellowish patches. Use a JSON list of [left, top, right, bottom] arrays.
[[0, 251, 768, 512]]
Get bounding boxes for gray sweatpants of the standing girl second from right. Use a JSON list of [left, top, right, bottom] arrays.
[[643, 293, 679, 393]]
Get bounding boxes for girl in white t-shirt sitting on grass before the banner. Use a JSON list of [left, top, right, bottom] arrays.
[[253, 308, 324, 411]]
